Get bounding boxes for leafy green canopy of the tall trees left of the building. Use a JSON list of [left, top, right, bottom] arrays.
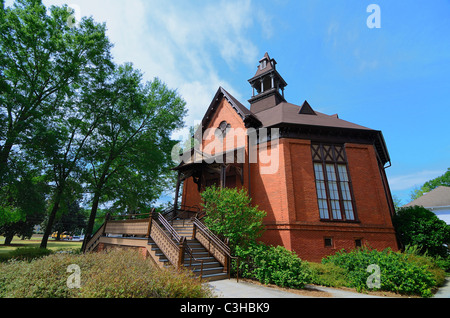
[[0, 0, 186, 248]]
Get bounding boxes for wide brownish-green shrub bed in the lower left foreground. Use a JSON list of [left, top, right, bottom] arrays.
[[0, 250, 211, 298]]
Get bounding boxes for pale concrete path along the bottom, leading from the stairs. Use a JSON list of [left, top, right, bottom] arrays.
[[208, 279, 380, 298]]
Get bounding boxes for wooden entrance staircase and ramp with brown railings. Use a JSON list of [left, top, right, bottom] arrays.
[[86, 210, 236, 281]]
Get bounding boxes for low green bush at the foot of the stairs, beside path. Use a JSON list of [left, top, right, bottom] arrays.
[[236, 243, 311, 289]]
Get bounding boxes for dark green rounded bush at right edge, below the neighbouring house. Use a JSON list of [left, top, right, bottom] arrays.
[[392, 206, 450, 258]]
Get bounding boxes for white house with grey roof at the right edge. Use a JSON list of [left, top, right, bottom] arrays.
[[404, 186, 450, 225]]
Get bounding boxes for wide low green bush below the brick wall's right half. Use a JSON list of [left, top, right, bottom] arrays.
[[322, 248, 437, 297]]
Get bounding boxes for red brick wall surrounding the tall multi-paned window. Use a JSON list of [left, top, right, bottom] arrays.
[[258, 139, 397, 262]]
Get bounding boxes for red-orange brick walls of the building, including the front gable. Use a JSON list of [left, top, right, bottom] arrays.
[[182, 100, 397, 261]]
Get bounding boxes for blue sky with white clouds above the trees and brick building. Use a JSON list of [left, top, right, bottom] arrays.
[[6, 0, 450, 203]]
